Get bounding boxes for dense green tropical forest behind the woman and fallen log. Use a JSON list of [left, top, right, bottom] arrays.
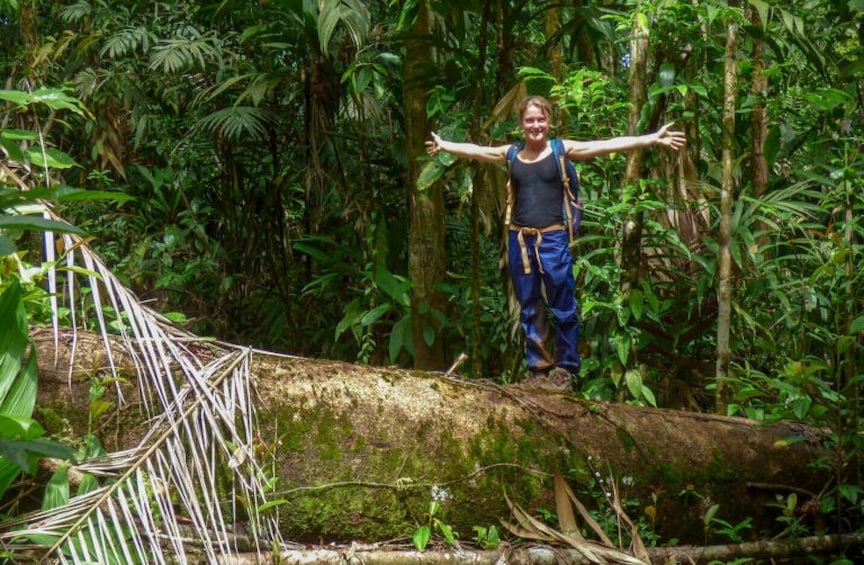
[[0, 0, 864, 424]]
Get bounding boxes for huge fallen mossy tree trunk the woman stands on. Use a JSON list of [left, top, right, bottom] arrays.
[[34, 326, 830, 545]]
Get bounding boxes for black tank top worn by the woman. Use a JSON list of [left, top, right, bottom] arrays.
[[510, 152, 564, 228]]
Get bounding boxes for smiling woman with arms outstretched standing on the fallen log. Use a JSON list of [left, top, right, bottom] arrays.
[[426, 96, 685, 391]]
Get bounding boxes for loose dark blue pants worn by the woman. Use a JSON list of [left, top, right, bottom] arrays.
[[508, 228, 582, 373]]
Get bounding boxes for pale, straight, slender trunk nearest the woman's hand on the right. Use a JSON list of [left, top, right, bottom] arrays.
[[714, 19, 738, 414]]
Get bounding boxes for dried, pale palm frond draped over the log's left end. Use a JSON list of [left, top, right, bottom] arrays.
[[0, 210, 281, 563]]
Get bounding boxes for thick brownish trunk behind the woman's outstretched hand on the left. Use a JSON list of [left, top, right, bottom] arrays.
[[403, 0, 446, 369]]
